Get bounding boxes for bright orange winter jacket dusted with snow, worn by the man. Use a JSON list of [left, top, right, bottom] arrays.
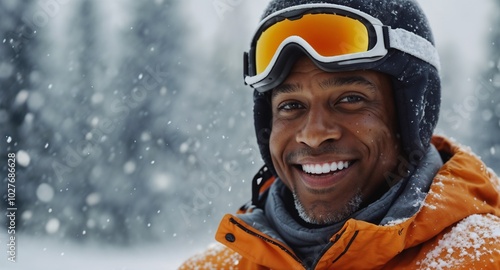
[[180, 136, 500, 270]]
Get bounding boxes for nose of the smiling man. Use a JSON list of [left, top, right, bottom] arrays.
[[296, 106, 342, 148]]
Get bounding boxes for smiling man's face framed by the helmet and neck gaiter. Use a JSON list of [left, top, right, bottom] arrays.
[[269, 58, 400, 224]]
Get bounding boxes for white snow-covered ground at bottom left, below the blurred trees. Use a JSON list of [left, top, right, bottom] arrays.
[[0, 234, 209, 270]]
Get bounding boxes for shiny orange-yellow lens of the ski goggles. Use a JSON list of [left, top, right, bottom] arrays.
[[255, 14, 370, 74]]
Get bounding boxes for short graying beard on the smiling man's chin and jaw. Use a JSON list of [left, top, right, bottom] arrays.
[[293, 190, 363, 225]]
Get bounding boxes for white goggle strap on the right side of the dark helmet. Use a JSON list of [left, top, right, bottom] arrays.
[[389, 28, 441, 71]]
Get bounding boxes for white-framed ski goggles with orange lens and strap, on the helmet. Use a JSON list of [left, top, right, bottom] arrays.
[[244, 4, 439, 92]]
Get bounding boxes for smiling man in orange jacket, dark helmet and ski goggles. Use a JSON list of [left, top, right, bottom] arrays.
[[181, 0, 500, 269]]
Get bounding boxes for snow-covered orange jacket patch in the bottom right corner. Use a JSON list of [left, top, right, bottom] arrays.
[[417, 215, 500, 269]]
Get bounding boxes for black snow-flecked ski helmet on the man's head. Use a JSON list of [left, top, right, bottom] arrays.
[[244, 0, 441, 175]]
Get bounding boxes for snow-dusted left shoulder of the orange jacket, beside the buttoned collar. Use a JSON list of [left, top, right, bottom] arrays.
[[179, 243, 241, 270]]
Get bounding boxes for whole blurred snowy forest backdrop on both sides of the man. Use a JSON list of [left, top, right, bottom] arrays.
[[0, 0, 500, 270]]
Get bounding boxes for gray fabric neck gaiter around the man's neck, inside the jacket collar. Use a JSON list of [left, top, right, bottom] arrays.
[[264, 146, 443, 265]]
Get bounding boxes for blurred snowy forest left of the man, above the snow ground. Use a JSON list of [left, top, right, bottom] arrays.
[[0, 0, 260, 248]]
